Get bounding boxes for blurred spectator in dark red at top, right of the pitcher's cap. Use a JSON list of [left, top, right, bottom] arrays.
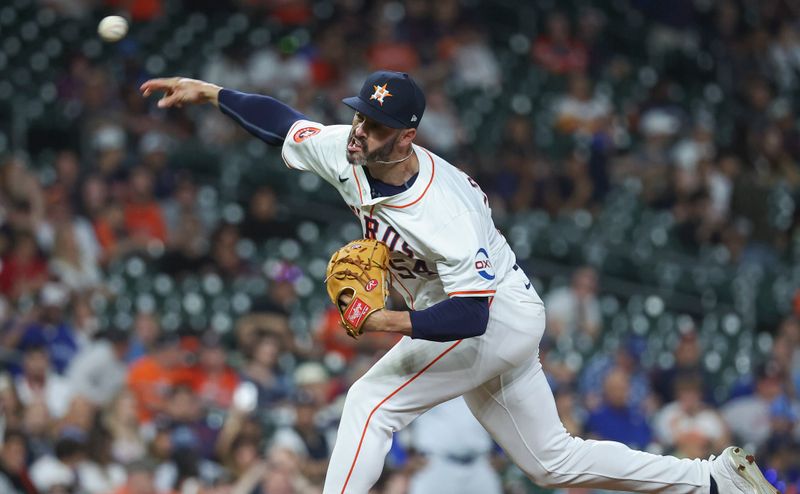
[[532, 12, 587, 74]]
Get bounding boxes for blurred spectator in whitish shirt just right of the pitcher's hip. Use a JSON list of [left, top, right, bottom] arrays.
[[545, 267, 601, 339]]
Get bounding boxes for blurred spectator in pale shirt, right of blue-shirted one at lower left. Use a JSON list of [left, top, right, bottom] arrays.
[[66, 329, 128, 406]]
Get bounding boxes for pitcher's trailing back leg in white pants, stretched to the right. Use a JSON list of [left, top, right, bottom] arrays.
[[464, 358, 710, 494]]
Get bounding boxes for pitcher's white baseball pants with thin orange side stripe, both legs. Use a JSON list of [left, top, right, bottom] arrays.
[[323, 270, 711, 494]]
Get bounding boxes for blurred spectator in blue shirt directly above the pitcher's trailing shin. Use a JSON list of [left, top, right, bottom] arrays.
[[586, 369, 652, 449]]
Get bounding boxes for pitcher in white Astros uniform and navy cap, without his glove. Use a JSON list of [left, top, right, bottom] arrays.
[[141, 71, 777, 494]]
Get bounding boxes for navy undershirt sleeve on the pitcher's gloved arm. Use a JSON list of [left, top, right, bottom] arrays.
[[411, 297, 489, 341]]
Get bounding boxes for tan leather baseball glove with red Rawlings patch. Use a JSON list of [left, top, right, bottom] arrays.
[[325, 238, 389, 338]]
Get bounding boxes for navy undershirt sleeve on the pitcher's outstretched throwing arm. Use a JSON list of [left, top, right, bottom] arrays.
[[219, 89, 308, 146]]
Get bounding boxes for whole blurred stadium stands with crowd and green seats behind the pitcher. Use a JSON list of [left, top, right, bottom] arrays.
[[0, 0, 800, 494]]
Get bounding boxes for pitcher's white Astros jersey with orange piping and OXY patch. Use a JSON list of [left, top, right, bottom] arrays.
[[282, 120, 516, 310]]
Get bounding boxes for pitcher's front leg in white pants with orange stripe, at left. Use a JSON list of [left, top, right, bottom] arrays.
[[323, 338, 481, 494]]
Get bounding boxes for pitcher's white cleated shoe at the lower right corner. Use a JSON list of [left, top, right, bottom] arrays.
[[710, 446, 780, 494]]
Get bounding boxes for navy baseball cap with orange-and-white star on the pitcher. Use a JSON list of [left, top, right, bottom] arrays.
[[342, 70, 425, 129]]
